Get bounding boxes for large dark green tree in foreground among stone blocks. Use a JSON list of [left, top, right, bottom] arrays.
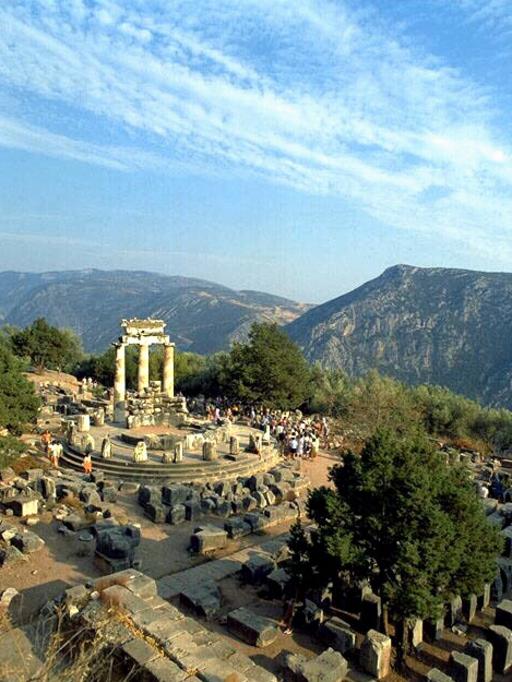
[[292, 430, 501, 659]]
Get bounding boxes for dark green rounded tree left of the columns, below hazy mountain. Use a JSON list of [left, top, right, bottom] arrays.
[[10, 318, 83, 371]]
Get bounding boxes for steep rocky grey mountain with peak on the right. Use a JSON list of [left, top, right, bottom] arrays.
[[286, 265, 512, 407]]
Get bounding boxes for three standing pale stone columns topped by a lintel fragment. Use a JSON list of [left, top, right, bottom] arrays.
[[114, 319, 186, 428]]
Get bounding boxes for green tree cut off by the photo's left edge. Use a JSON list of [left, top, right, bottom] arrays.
[[0, 344, 40, 434]]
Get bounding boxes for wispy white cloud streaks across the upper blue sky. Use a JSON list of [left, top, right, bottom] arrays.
[[0, 0, 512, 259]]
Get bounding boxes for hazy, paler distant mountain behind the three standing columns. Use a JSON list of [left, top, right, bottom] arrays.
[[0, 270, 310, 353]]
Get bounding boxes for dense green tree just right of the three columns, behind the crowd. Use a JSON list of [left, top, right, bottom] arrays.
[[225, 322, 310, 409]]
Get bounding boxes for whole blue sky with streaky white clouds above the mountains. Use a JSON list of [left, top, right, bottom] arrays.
[[0, 0, 512, 303]]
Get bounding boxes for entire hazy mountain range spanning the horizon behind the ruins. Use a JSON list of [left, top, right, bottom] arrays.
[[0, 265, 512, 407]]
